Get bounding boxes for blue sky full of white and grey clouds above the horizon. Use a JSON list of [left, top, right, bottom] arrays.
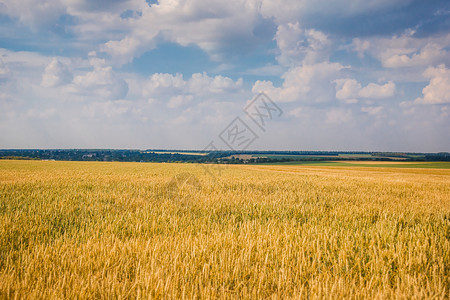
[[0, 0, 450, 152]]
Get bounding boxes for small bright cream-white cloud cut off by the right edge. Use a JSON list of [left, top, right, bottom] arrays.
[[415, 65, 450, 104]]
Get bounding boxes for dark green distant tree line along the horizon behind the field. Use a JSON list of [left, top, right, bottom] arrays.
[[0, 149, 450, 164]]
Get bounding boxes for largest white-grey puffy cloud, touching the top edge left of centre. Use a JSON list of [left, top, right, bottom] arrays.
[[101, 0, 270, 64]]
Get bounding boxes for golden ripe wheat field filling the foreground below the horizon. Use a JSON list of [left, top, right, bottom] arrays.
[[0, 160, 450, 299]]
